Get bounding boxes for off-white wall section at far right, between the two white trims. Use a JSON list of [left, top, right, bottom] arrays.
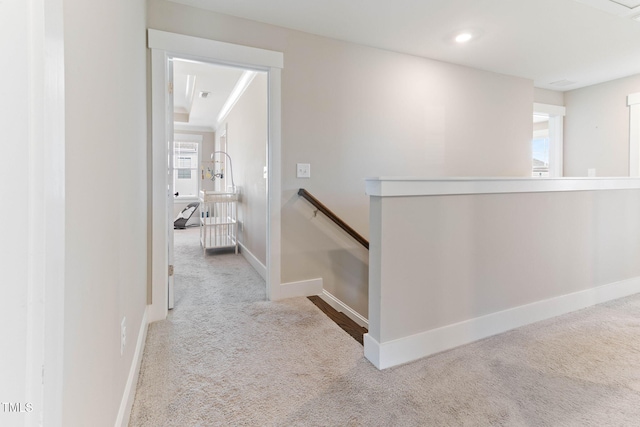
[[564, 75, 640, 176]]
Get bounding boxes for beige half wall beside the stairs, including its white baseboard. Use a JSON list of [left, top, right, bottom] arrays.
[[365, 179, 640, 368]]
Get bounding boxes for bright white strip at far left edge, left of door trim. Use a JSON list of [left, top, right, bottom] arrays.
[[0, 0, 31, 425]]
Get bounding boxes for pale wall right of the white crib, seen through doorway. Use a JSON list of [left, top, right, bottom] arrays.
[[225, 73, 268, 265]]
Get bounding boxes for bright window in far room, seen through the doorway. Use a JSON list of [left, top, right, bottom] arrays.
[[173, 142, 200, 198]]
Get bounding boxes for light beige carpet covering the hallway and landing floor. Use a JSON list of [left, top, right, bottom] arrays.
[[130, 229, 640, 427]]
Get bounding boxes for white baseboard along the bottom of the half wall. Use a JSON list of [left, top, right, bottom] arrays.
[[364, 277, 640, 369]]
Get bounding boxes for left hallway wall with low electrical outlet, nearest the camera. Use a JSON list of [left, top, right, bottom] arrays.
[[63, 0, 147, 427]]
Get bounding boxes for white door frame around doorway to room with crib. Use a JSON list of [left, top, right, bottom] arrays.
[[148, 29, 284, 322]]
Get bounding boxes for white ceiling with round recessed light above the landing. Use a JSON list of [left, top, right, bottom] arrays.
[[172, 0, 640, 91]]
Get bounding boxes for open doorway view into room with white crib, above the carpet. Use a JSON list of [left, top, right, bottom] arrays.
[[169, 60, 268, 309]]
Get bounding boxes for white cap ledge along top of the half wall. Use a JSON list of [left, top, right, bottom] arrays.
[[366, 177, 640, 197]]
